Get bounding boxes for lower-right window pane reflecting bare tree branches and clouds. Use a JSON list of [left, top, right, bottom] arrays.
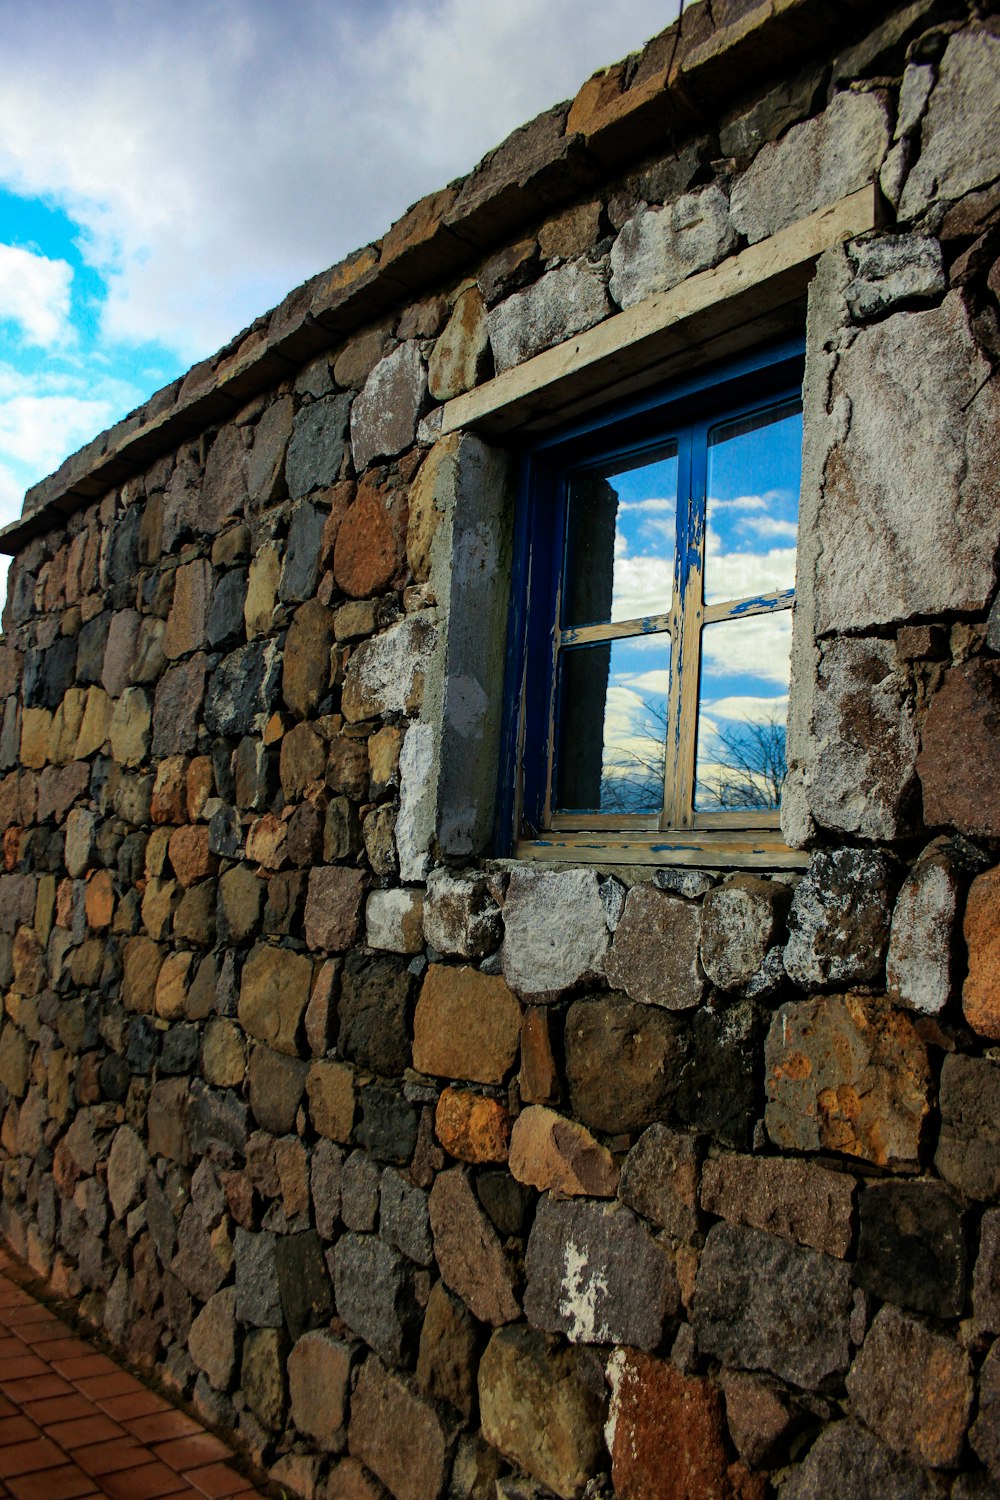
[[694, 609, 792, 813]]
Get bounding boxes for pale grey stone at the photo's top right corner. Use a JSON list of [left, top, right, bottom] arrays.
[[900, 29, 1000, 219]]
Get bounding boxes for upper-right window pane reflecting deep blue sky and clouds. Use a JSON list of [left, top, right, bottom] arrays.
[[705, 401, 802, 605]]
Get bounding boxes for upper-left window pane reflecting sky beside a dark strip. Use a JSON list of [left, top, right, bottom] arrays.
[[562, 443, 678, 627]]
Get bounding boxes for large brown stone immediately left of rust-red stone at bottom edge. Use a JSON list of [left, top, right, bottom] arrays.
[[480, 1326, 606, 1500]]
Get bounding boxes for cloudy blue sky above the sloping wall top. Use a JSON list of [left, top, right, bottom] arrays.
[[0, 0, 678, 564]]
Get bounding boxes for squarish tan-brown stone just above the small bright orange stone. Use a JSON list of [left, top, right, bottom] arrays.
[[414, 963, 520, 1083]]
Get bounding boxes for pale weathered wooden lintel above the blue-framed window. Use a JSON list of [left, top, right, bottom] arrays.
[[441, 185, 879, 437]]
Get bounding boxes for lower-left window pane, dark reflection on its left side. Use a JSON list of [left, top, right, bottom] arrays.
[[553, 633, 670, 815]]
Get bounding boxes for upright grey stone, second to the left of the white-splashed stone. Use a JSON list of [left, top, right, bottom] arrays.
[[333, 1233, 421, 1368]]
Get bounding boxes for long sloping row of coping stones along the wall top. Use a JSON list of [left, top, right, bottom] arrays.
[[0, 0, 894, 555]]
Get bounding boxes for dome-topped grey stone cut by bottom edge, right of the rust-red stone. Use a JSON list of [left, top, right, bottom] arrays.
[[781, 1422, 948, 1500]]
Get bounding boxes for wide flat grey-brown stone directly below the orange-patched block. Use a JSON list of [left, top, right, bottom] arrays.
[[702, 1155, 855, 1260]]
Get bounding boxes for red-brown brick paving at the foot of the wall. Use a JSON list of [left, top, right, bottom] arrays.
[[0, 1247, 269, 1500]]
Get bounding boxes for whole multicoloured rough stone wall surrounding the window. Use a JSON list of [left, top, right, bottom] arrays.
[[0, 0, 1000, 1500]]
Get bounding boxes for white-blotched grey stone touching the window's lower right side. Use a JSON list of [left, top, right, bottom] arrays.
[[805, 638, 918, 840]]
